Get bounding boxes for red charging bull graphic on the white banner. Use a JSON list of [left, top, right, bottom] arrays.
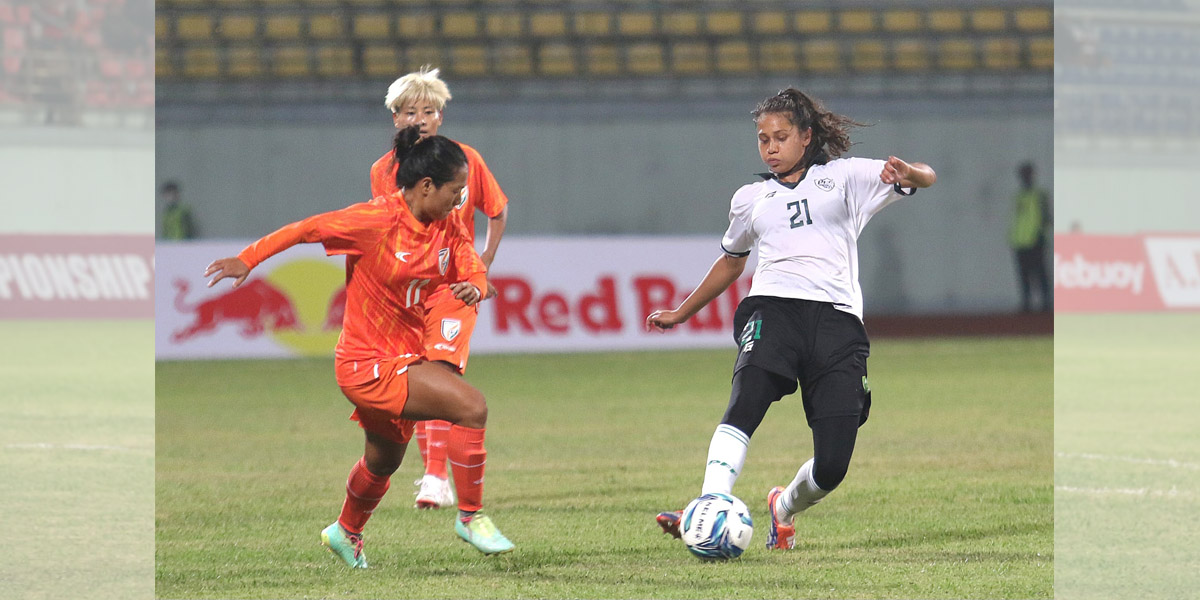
[[170, 280, 304, 343]]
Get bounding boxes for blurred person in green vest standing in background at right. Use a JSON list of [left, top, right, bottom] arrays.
[[1008, 162, 1051, 312]]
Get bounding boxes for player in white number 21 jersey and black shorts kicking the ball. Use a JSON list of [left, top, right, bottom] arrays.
[[646, 88, 937, 550]]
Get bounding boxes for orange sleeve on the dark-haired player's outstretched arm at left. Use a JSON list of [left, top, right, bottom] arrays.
[[238, 203, 391, 269]]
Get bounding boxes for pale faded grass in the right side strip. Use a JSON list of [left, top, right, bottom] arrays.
[[1055, 314, 1200, 600]]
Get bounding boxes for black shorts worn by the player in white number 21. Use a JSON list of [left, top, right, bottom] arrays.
[[733, 296, 871, 424]]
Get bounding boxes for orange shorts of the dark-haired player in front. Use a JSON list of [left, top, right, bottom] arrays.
[[342, 356, 420, 444]]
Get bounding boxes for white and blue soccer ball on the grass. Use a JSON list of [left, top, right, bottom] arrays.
[[679, 493, 754, 560]]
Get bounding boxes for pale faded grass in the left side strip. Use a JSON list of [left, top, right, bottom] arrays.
[[0, 320, 154, 600]]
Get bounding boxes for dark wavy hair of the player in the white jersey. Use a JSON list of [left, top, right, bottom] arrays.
[[752, 88, 866, 167]]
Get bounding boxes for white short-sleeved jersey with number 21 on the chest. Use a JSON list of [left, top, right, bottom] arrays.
[[721, 158, 914, 320]]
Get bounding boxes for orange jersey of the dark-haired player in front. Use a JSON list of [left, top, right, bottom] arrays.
[[238, 193, 487, 386]]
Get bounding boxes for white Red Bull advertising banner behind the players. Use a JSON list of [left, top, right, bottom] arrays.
[[155, 236, 754, 359]]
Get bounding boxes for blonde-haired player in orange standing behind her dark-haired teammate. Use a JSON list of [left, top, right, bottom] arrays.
[[371, 67, 509, 509]]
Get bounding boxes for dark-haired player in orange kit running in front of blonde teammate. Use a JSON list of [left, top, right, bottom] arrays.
[[204, 126, 512, 569]]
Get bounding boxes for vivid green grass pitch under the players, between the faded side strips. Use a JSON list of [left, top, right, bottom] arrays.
[[156, 337, 1054, 599]]
